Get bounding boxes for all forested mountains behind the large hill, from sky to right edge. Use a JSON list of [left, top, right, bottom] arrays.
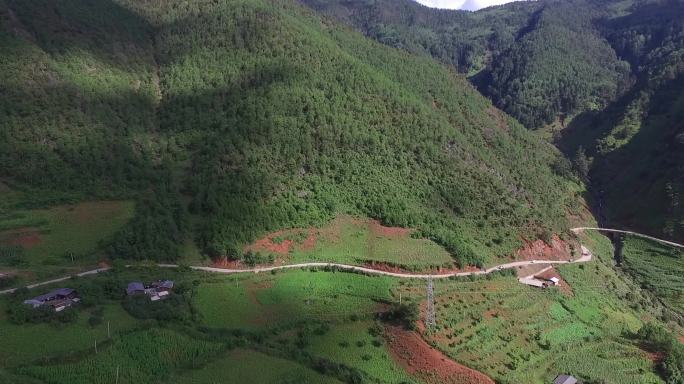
[[302, 0, 684, 240]]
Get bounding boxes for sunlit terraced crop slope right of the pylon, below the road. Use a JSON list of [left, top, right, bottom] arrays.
[[402, 231, 662, 384]]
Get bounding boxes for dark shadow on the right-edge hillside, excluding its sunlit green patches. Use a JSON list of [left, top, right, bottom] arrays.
[[559, 71, 684, 240]]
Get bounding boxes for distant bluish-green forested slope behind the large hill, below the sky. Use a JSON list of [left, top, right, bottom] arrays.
[[302, 0, 629, 128]]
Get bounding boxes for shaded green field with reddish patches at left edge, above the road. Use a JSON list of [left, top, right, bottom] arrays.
[[0, 201, 134, 271]]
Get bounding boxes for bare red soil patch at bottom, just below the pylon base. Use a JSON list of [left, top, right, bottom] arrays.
[[386, 326, 494, 384]]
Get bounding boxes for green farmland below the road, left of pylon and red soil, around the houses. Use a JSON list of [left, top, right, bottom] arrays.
[[0, 268, 411, 384]]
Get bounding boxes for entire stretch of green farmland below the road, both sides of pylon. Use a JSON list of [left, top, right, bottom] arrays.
[[0, 231, 676, 384]]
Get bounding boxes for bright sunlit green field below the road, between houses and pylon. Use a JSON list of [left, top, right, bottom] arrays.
[[194, 271, 393, 329]]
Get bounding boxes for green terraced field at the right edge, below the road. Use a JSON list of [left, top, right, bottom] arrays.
[[622, 236, 684, 314]]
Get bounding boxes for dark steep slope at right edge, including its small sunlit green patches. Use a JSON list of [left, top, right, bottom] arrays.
[[562, 1, 684, 240]]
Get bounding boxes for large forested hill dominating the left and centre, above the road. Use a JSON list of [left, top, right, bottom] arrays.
[[0, 0, 575, 264]]
